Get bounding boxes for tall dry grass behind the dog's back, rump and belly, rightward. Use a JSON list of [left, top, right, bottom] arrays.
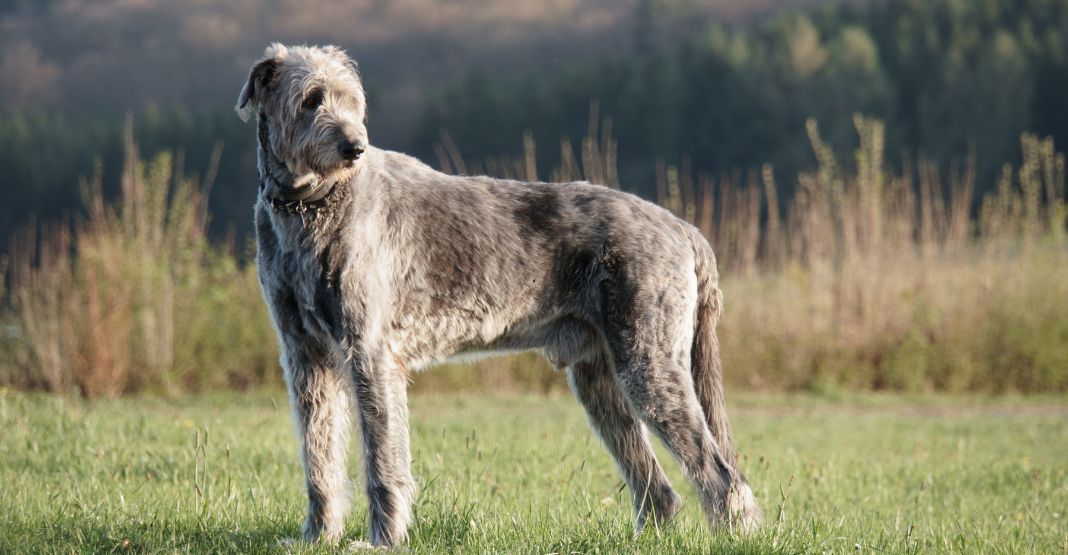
[[434, 110, 1068, 392]]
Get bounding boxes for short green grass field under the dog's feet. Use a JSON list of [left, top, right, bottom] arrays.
[[0, 392, 1068, 553]]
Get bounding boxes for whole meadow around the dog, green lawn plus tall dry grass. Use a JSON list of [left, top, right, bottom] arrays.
[[0, 111, 1068, 553]]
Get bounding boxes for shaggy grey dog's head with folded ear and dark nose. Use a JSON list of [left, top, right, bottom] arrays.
[[236, 43, 368, 188]]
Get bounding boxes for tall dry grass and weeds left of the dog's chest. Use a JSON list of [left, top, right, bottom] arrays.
[[0, 116, 279, 396]]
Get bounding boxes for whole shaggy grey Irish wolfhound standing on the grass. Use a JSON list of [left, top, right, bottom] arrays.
[[237, 44, 759, 545]]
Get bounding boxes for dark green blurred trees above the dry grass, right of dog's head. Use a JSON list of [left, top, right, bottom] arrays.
[[414, 0, 1068, 197]]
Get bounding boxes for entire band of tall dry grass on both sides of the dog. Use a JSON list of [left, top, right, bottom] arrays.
[[0, 109, 1068, 396]]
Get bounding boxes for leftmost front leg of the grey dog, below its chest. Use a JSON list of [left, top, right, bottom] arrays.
[[282, 337, 351, 542]]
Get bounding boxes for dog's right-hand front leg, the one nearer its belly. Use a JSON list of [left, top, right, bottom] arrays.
[[351, 349, 415, 546]]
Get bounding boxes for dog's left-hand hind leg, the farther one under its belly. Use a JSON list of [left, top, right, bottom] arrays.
[[567, 356, 681, 535]]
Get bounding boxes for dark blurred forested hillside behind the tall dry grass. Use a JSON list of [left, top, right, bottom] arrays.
[[0, 0, 1068, 254]]
